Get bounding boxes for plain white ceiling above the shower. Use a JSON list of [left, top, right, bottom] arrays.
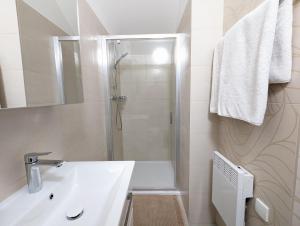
[[87, 0, 187, 35]]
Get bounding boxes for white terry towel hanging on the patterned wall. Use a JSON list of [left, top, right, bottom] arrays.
[[210, 0, 293, 125]]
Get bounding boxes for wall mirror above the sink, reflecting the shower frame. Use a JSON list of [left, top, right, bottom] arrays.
[[0, 0, 83, 109]]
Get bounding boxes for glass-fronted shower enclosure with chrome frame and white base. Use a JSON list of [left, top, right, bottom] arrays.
[[101, 34, 181, 190]]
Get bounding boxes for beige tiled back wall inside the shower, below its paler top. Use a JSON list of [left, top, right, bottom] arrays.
[[120, 59, 175, 161]]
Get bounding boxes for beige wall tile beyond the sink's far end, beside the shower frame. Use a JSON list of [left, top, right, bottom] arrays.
[[60, 102, 107, 161]]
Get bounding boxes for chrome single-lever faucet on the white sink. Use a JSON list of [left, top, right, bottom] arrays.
[[24, 152, 63, 193]]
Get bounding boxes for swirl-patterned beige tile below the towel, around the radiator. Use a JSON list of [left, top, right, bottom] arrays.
[[220, 104, 300, 226]]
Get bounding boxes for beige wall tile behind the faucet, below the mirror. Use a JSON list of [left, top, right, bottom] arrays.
[[0, 108, 62, 200]]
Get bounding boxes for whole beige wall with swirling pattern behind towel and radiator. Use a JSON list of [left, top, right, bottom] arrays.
[[219, 0, 300, 226]]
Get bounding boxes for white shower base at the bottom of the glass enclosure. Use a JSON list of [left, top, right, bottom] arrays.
[[132, 161, 175, 190]]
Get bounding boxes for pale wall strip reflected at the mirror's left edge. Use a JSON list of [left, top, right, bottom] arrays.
[[0, 0, 26, 108]]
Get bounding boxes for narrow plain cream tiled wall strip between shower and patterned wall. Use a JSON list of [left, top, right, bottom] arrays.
[[189, 0, 223, 226]]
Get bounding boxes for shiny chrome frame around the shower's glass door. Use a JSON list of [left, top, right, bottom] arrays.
[[98, 34, 187, 190]]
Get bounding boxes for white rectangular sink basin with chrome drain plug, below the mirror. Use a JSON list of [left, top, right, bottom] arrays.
[[0, 162, 134, 226]]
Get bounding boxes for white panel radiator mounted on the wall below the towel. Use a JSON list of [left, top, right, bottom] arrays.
[[212, 151, 254, 226]]
